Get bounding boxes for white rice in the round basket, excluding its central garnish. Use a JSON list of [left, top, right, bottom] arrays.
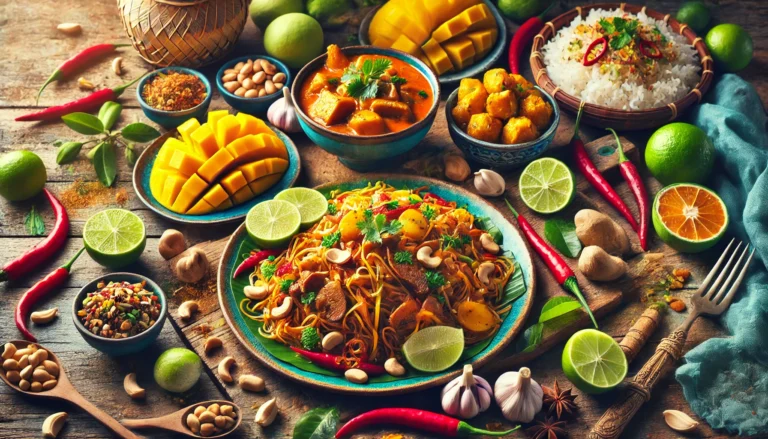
[[542, 9, 701, 110]]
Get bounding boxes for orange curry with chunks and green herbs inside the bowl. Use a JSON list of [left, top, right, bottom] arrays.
[[299, 45, 434, 136]]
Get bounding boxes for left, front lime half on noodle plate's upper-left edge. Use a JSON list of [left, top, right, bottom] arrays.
[[245, 200, 301, 248]]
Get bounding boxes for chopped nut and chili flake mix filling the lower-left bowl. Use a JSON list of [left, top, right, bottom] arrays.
[[77, 281, 161, 338]]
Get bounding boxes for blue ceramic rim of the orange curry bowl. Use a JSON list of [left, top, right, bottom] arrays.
[[291, 46, 441, 144]]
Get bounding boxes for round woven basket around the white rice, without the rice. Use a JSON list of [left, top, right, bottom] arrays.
[[530, 3, 714, 130]]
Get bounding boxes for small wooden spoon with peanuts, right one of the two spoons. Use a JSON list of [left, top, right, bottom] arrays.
[[120, 400, 243, 439]]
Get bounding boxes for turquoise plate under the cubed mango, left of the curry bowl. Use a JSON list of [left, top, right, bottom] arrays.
[[133, 125, 301, 224]]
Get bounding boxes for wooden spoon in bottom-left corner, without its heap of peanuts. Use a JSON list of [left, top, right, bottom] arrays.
[[0, 340, 140, 439]]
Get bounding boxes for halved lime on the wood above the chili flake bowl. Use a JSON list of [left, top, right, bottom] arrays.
[[83, 209, 147, 268]]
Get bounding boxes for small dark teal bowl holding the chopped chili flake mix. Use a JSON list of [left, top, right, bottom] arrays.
[[72, 273, 168, 357]]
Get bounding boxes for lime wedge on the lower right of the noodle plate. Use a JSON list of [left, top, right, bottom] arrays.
[[403, 326, 464, 372]]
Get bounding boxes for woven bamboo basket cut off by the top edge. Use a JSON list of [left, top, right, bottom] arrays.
[[117, 0, 248, 67]]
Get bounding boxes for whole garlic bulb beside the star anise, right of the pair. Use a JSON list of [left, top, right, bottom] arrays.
[[493, 367, 544, 422]]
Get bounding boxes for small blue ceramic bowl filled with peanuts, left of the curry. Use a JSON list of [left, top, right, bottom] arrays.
[[216, 55, 291, 114]]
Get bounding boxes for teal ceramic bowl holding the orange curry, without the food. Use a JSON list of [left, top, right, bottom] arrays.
[[291, 46, 440, 172]]
